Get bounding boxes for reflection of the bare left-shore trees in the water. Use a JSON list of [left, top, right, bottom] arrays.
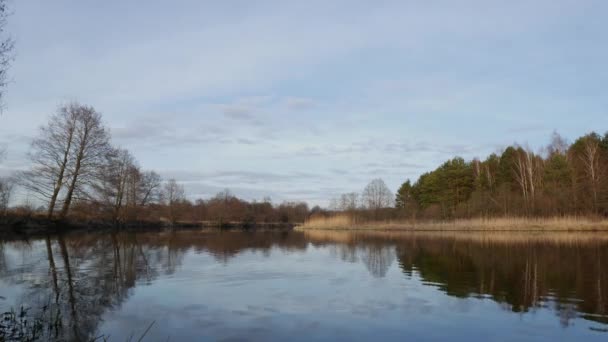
[[0, 232, 307, 341]]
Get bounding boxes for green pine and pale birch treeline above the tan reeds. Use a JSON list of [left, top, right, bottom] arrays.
[[330, 133, 608, 219]]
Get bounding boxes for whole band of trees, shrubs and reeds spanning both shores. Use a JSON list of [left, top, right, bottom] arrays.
[[0, 103, 608, 230]]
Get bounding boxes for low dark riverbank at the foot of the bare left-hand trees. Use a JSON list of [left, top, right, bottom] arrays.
[[0, 216, 295, 237]]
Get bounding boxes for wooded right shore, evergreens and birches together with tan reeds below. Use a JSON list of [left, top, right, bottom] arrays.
[[316, 132, 608, 230]]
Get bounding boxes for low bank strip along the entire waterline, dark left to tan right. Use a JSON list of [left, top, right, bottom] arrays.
[[0, 214, 608, 238]]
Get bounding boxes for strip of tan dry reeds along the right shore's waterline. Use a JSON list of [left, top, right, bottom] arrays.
[[297, 214, 608, 231]]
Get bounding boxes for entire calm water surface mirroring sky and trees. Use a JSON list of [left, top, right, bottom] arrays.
[[0, 232, 608, 341]]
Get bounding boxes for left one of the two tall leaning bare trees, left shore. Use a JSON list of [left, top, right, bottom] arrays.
[[20, 104, 78, 218]]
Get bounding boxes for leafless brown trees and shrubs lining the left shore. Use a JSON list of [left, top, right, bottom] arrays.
[[0, 103, 308, 225]]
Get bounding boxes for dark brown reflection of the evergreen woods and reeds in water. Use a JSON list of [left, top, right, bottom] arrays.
[[306, 231, 608, 326]]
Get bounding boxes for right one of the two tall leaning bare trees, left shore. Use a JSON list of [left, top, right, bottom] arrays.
[[60, 103, 111, 218]]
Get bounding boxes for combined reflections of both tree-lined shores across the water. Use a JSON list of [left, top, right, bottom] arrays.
[[0, 231, 608, 341]]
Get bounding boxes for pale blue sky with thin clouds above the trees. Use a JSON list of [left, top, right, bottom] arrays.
[[0, 0, 608, 205]]
